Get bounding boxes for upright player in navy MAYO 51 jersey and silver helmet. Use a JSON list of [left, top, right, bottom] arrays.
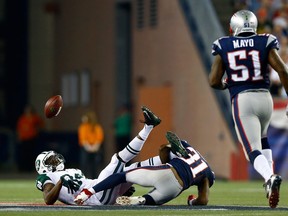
[[209, 10, 288, 208]]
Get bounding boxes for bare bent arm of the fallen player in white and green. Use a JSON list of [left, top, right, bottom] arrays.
[[43, 180, 62, 205]]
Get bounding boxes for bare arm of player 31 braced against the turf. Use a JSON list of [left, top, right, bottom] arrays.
[[188, 178, 209, 205]]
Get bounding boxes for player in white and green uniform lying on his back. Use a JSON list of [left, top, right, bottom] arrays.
[[35, 106, 162, 205]]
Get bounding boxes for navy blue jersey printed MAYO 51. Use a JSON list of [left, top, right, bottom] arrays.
[[212, 34, 279, 98]]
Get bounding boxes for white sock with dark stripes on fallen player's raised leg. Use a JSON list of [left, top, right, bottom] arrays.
[[118, 124, 153, 162]]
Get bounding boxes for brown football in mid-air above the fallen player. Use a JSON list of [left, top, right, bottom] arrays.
[[44, 95, 63, 118]]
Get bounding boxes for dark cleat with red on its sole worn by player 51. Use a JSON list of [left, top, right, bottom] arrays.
[[263, 175, 282, 208]]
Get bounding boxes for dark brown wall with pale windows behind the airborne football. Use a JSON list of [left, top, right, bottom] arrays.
[[29, 0, 117, 162]]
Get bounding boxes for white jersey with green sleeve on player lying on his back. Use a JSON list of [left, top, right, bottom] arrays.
[[36, 169, 102, 205]]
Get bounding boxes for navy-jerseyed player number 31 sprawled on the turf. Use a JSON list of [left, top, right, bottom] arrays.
[[75, 132, 215, 205]]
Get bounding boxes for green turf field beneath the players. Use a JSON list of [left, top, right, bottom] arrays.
[[0, 180, 288, 216]]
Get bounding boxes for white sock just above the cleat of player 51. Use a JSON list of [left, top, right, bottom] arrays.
[[253, 154, 273, 182]]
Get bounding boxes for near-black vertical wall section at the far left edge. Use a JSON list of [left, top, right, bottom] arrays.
[[0, 0, 29, 130]]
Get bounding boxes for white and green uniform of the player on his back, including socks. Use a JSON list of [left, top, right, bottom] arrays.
[[36, 124, 161, 205]]
